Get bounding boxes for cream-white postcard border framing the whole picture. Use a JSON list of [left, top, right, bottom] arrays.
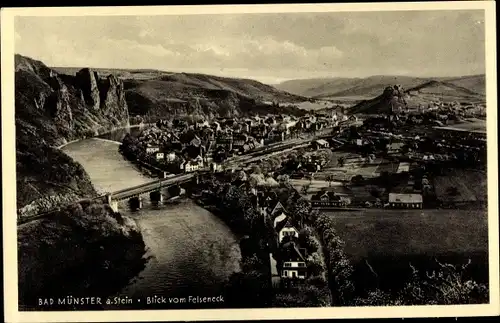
[[1, 1, 500, 322]]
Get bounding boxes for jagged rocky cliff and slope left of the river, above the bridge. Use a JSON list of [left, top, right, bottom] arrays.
[[15, 55, 129, 211]]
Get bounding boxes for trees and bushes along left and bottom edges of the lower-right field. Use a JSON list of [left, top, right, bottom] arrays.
[[308, 214, 488, 306]]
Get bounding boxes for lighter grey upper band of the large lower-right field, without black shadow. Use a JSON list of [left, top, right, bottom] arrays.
[[326, 209, 488, 259]]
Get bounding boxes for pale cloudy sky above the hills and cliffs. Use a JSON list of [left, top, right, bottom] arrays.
[[15, 10, 485, 83]]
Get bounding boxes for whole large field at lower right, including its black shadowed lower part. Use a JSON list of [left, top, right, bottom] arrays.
[[327, 209, 488, 291]]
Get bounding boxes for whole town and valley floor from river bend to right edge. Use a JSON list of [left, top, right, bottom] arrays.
[[120, 91, 486, 306]]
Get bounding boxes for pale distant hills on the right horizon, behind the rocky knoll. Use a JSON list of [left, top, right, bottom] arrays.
[[276, 75, 485, 100]]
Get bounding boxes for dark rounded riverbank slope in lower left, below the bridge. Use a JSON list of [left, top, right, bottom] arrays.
[[18, 202, 145, 311]]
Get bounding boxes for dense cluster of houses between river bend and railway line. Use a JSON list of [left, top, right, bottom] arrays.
[[139, 114, 339, 172]]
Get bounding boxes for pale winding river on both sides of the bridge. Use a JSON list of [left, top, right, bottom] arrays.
[[63, 130, 241, 309]]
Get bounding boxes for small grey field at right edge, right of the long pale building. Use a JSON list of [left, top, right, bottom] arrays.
[[434, 169, 487, 202]]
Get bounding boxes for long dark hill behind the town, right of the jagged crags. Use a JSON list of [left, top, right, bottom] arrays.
[[55, 68, 308, 120]]
